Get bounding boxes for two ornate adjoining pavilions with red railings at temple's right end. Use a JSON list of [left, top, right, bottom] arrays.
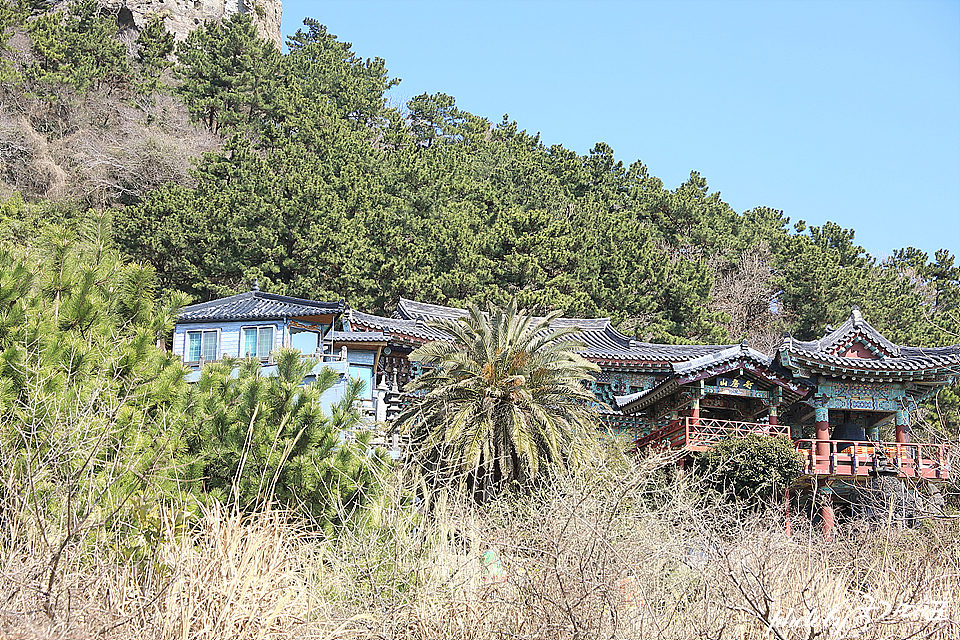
[[615, 307, 960, 531]]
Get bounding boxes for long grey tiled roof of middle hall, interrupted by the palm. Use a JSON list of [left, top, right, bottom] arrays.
[[356, 298, 729, 365]]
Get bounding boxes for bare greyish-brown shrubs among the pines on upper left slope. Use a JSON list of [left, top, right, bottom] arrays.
[[0, 74, 222, 207]]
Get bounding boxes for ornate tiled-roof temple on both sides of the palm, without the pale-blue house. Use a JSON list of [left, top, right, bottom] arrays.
[[344, 299, 960, 532]]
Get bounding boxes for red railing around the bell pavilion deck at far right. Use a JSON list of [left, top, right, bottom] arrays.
[[794, 439, 955, 480]]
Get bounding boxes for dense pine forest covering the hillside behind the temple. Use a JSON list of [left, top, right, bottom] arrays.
[[0, 1, 960, 340]]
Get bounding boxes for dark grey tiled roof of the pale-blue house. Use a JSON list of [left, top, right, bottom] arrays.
[[177, 288, 344, 322]]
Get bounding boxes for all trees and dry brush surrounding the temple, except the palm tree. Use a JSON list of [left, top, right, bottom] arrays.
[[0, 5, 960, 639]]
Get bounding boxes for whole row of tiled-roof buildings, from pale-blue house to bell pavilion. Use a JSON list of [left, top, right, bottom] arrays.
[[173, 287, 960, 531]]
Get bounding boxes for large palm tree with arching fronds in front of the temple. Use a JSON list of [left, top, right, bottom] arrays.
[[397, 300, 599, 503]]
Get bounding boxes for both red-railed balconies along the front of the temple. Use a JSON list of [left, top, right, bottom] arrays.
[[637, 418, 960, 480]]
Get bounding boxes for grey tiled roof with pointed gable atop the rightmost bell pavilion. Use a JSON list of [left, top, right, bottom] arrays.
[[777, 307, 960, 381]]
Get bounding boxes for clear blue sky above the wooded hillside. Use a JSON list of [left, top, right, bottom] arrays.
[[274, 0, 960, 257]]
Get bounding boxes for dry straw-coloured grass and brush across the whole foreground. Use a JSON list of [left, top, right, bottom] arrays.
[[0, 450, 960, 639]]
